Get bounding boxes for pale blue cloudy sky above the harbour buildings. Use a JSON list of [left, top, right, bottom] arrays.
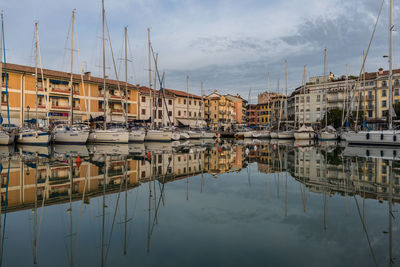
[[0, 0, 400, 103]]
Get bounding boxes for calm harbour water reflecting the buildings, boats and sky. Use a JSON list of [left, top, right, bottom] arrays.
[[0, 141, 400, 267]]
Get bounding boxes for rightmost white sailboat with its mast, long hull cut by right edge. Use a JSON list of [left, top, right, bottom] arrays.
[[342, 0, 400, 146]]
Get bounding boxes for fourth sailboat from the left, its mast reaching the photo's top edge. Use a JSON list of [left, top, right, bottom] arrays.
[[88, 0, 129, 143]]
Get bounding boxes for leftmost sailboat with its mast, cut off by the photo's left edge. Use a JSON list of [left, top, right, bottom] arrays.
[[0, 13, 15, 145]]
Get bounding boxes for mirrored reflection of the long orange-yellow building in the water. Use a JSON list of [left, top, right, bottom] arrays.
[[1, 159, 139, 214]]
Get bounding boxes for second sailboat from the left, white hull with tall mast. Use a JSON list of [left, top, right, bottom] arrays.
[[17, 22, 51, 145]]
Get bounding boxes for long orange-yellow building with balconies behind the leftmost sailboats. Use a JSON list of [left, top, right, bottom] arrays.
[[1, 63, 138, 125]]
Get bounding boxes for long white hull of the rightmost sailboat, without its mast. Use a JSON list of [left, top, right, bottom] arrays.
[[343, 130, 400, 146]]
